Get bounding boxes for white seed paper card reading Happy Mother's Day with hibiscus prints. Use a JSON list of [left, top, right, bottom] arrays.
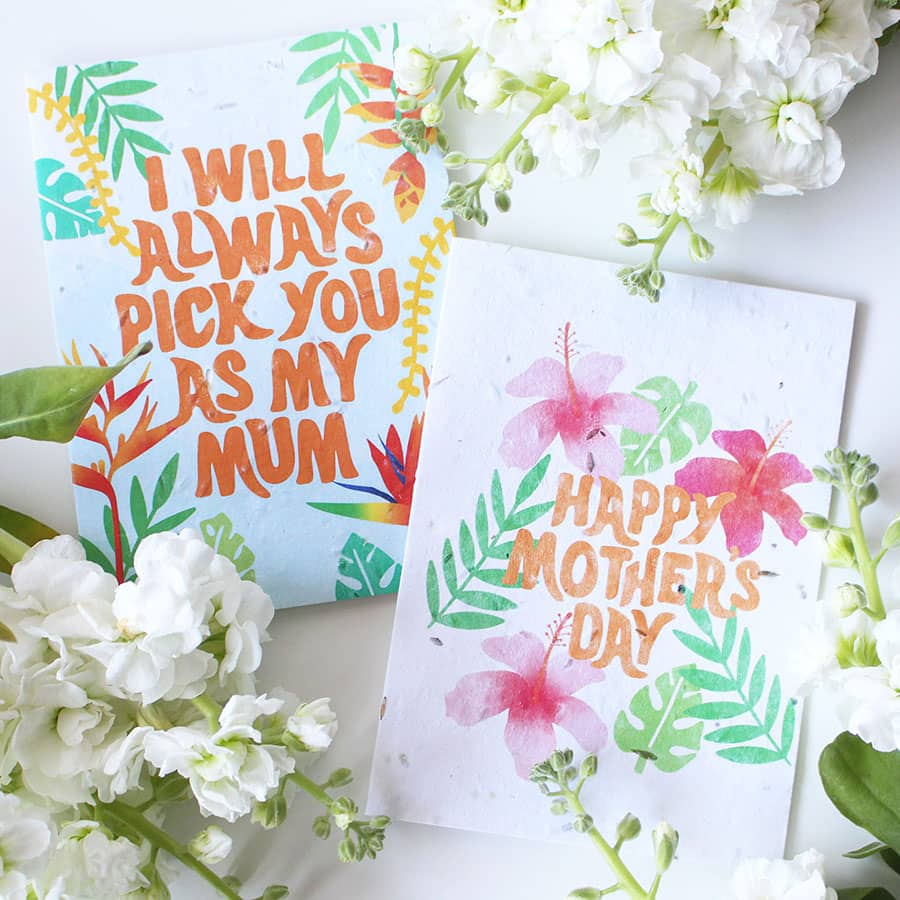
[[369, 240, 853, 884]]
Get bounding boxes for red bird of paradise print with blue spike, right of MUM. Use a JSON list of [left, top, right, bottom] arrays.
[[309, 416, 424, 525]]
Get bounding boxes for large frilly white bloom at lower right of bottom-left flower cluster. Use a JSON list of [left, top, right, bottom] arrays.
[[144, 695, 294, 822]]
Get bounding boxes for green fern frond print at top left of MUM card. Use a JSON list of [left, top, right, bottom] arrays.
[[54, 61, 169, 181]]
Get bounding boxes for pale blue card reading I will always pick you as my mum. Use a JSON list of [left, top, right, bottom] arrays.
[[27, 25, 453, 606]]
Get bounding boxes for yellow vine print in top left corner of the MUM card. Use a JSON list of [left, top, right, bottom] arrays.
[[28, 82, 141, 256]]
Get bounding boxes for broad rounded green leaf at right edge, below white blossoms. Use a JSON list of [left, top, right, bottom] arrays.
[[819, 731, 900, 852]]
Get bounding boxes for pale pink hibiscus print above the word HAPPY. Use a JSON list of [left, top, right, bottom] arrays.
[[500, 322, 659, 481]]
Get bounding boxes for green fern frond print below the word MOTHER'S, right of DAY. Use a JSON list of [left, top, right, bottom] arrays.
[[673, 590, 797, 765]]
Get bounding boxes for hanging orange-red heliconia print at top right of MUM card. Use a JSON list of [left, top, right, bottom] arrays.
[[345, 63, 437, 222]]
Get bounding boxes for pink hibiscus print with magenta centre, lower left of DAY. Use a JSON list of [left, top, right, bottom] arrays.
[[446, 613, 607, 778]]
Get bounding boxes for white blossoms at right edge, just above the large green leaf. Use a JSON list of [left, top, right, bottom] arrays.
[[796, 571, 900, 752]]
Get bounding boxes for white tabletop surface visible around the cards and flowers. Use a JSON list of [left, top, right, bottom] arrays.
[[0, 0, 900, 900]]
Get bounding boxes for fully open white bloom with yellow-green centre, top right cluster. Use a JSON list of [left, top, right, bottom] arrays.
[[720, 59, 849, 195]]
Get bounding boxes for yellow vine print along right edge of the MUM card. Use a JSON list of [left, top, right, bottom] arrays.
[[392, 217, 456, 413]]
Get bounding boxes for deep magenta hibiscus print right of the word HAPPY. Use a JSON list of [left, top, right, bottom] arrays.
[[675, 423, 812, 556]]
